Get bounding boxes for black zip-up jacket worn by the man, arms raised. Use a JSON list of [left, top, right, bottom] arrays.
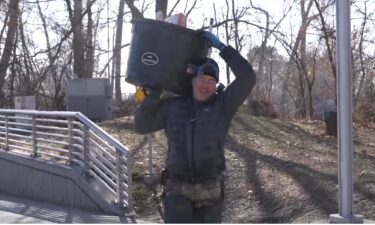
[[134, 46, 255, 177]]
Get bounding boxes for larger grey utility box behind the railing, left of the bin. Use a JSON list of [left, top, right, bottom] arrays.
[[65, 79, 112, 120]]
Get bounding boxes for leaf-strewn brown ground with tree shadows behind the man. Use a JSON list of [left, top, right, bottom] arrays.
[[101, 115, 375, 223]]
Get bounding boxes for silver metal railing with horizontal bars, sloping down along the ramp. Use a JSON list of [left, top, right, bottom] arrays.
[[0, 109, 132, 210]]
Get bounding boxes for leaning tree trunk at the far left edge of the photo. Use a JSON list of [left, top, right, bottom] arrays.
[[0, 0, 19, 106]]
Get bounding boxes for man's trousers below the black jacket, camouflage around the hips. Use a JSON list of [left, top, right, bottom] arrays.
[[164, 176, 223, 223]]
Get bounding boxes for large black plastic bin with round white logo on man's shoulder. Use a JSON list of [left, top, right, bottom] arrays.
[[125, 19, 208, 95]]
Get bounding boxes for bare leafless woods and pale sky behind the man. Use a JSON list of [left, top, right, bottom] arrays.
[[0, 0, 375, 122]]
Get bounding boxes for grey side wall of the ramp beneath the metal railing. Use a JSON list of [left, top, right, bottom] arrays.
[[0, 151, 120, 214]]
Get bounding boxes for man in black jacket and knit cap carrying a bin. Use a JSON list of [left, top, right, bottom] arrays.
[[134, 32, 255, 223]]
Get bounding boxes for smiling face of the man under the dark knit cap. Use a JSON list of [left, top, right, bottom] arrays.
[[192, 75, 217, 102]]
